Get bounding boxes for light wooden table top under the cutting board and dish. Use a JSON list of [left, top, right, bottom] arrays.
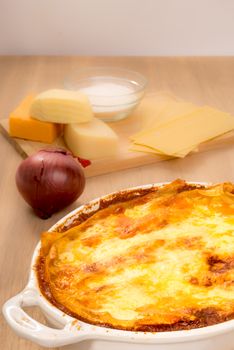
[[0, 57, 234, 350]]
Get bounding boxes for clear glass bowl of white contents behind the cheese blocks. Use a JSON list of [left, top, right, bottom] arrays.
[[64, 67, 147, 122]]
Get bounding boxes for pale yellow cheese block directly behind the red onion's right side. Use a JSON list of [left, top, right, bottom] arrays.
[[64, 118, 118, 160]]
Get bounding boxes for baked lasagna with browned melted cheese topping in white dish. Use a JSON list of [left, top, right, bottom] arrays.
[[36, 180, 234, 332]]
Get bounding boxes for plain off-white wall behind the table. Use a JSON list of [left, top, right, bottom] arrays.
[[0, 0, 234, 55]]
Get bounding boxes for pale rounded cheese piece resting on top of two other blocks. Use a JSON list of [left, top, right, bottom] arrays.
[[30, 89, 93, 124]]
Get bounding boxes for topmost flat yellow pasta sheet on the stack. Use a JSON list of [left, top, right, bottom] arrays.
[[134, 106, 234, 155]]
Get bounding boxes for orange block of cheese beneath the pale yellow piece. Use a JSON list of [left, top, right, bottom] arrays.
[[9, 95, 62, 143]]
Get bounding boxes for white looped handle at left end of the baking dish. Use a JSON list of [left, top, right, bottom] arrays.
[[3, 292, 90, 347]]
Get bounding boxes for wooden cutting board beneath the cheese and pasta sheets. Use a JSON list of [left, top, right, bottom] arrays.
[[0, 115, 234, 177]]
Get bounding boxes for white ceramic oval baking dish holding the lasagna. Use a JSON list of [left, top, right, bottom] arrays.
[[3, 182, 234, 350]]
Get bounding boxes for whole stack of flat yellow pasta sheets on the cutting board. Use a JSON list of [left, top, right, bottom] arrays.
[[130, 92, 234, 158]]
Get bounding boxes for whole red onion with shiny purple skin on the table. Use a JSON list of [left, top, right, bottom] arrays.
[[15, 148, 85, 219]]
